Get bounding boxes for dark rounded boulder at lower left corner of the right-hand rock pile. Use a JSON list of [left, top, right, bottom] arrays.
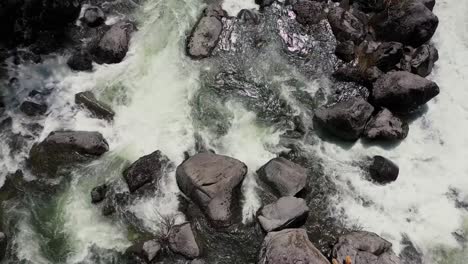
[[314, 98, 374, 141]]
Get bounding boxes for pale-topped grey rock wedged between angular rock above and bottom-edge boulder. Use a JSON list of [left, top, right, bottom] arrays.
[[258, 196, 309, 232]]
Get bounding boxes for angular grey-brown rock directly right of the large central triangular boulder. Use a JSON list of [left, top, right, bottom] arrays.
[[257, 157, 307, 196]]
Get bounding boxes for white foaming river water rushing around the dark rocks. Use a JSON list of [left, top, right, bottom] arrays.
[[1, 0, 468, 264]]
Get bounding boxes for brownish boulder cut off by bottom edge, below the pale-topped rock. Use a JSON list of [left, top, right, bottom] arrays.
[[258, 229, 330, 264]]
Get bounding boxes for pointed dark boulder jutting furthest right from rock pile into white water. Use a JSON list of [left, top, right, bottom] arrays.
[[372, 71, 439, 112]]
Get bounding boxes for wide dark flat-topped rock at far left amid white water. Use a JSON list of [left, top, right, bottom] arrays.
[[29, 131, 109, 177]]
